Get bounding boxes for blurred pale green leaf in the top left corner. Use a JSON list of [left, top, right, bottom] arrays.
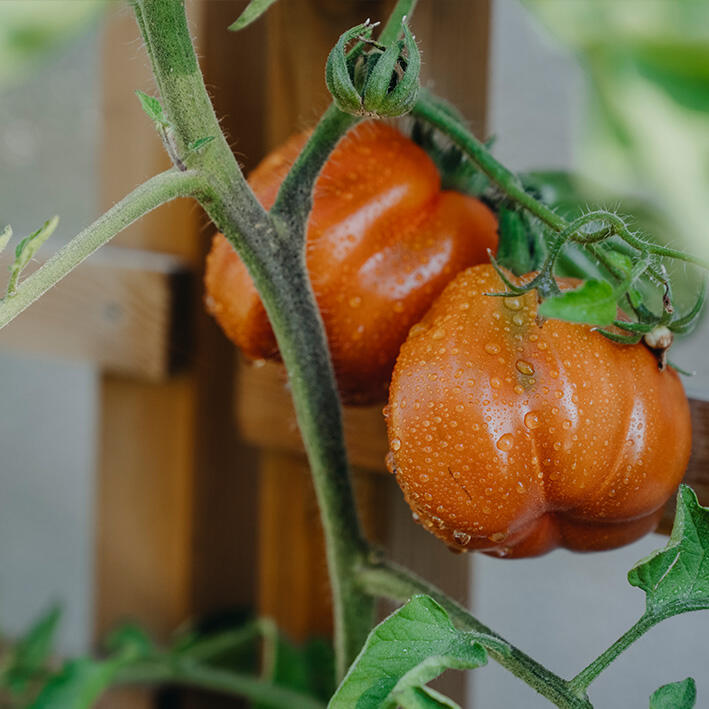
[[0, 0, 106, 89]]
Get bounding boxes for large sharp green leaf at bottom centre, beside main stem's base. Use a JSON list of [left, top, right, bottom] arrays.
[[328, 596, 498, 709]]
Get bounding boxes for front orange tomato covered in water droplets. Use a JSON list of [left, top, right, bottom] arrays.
[[387, 265, 691, 557]]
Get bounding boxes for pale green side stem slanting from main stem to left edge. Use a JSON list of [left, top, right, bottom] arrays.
[[0, 170, 203, 328]]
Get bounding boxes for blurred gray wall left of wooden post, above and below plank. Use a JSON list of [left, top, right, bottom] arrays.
[[0, 31, 100, 652]]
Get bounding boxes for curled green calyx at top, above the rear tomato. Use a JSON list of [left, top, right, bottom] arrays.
[[325, 21, 421, 118]]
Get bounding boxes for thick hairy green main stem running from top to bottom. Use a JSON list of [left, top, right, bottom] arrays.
[[135, 0, 374, 676]]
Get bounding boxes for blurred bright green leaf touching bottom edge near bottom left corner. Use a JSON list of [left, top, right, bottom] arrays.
[[29, 659, 121, 709]]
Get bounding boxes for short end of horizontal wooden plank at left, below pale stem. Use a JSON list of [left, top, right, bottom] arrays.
[[0, 247, 193, 381]]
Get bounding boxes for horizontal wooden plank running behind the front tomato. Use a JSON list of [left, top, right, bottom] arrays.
[[236, 362, 709, 531]]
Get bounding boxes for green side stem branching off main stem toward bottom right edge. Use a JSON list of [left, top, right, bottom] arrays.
[[358, 561, 591, 709]]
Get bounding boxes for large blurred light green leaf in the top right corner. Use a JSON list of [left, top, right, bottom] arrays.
[[525, 0, 709, 266]]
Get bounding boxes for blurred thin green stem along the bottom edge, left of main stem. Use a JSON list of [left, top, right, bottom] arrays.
[[115, 660, 325, 709]]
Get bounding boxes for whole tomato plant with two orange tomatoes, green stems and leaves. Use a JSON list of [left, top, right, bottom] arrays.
[[0, 0, 709, 709]]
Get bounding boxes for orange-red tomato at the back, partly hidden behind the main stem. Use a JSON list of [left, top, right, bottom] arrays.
[[205, 122, 497, 403]]
